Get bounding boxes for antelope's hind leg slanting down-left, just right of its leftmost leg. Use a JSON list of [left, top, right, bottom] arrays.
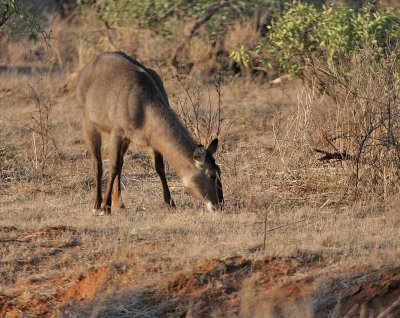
[[100, 131, 123, 215]]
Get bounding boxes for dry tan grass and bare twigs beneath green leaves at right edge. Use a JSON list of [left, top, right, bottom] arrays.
[[308, 47, 400, 198]]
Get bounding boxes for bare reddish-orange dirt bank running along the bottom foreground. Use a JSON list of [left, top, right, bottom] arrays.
[[0, 232, 400, 317]]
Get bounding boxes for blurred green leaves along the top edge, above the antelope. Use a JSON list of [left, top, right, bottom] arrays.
[[81, 0, 283, 39]]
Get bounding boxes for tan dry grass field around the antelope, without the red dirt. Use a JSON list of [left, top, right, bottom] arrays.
[[0, 11, 400, 316]]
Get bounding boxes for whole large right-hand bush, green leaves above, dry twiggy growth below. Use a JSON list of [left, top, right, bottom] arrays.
[[231, 1, 400, 198]]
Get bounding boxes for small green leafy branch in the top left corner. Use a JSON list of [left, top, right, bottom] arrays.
[[0, 0, 50, 41]]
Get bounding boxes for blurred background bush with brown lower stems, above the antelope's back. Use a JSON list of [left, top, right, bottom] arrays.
[[79, 0, 284, 70]]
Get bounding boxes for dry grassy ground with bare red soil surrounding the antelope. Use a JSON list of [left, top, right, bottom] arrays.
[[0, 4, 400, 317]]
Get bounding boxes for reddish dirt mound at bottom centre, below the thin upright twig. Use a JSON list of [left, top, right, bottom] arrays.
[[150, 257, 325, 317]]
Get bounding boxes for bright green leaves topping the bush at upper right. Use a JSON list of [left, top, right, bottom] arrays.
[[231, 1, 400, 74]]
